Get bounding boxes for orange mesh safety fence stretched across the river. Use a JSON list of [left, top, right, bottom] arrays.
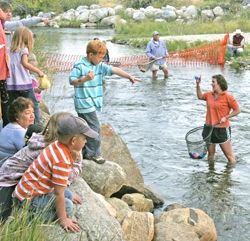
[[43, 33, 229, 72]]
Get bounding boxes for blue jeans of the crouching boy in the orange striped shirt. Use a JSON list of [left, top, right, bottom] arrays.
[[16, 188, 73, 221]]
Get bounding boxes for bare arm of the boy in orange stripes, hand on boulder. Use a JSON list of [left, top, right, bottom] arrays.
[[54, 185, 80, 232]]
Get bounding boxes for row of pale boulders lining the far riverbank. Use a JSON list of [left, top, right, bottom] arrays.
[[15, 2, 250, 28]]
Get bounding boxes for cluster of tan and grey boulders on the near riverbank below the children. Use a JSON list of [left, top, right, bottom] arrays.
[[37, 114, 217, 241]]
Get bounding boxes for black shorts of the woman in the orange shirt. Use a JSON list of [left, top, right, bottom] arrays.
[[202, 125, 231, 144]]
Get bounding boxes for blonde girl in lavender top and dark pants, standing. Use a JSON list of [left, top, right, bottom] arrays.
[[7, 27, 44, 123]]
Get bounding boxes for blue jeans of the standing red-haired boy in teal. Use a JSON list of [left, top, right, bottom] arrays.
[[77, 111, 101, 158]]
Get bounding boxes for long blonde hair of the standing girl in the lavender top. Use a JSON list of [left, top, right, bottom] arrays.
[[10, 27, 34, 52]]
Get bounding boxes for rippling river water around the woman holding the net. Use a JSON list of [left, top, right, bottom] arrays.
[[38, 29, 250, 241]]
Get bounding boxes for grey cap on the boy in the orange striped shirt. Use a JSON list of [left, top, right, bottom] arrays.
[[58, 115, 98, 139]]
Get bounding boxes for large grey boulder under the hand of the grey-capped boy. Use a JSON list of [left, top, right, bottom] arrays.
[[44, 177, 124, 241]]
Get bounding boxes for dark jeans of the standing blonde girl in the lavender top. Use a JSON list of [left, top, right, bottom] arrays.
[[8, 89, 40, 123]]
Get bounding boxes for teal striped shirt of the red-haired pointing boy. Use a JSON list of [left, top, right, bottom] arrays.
[[69, 57, 112, 113]]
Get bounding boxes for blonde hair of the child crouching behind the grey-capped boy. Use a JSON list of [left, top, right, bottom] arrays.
[[42, 112, 71, 145]]
